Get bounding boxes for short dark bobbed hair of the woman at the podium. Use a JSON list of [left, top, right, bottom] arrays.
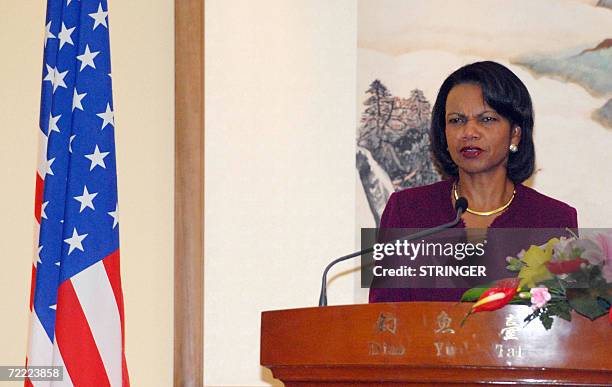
[[431, 61, 535, 184]]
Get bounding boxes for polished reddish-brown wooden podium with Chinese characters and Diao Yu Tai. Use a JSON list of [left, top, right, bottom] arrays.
[[261, 302, 612, 387]]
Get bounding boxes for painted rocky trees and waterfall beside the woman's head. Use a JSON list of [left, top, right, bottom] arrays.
[[357, 79, 440, 226]]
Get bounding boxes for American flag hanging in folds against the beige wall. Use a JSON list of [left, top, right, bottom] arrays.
[[25, 0, 129, 386]]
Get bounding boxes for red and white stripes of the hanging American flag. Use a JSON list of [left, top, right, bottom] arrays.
[[25, 131, 129, 387]]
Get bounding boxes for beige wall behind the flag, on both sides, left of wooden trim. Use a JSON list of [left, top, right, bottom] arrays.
[[0, 0, 174, 386]]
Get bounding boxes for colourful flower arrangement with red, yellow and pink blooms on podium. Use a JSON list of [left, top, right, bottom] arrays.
[[461, 231, 612, 329]]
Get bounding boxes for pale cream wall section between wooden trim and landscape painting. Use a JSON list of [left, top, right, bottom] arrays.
[[204, 0, 356, 386]]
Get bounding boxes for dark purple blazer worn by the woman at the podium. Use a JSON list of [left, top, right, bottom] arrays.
[[369, 180, 578, 302]]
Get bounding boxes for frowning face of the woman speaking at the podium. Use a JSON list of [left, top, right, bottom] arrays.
[[445, 84, 521, 178]]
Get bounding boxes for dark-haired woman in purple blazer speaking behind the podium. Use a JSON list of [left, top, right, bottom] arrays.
[[370, 61, 578, 302]]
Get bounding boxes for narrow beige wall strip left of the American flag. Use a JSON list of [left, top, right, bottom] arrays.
[[0, 1, 45, 386]]
